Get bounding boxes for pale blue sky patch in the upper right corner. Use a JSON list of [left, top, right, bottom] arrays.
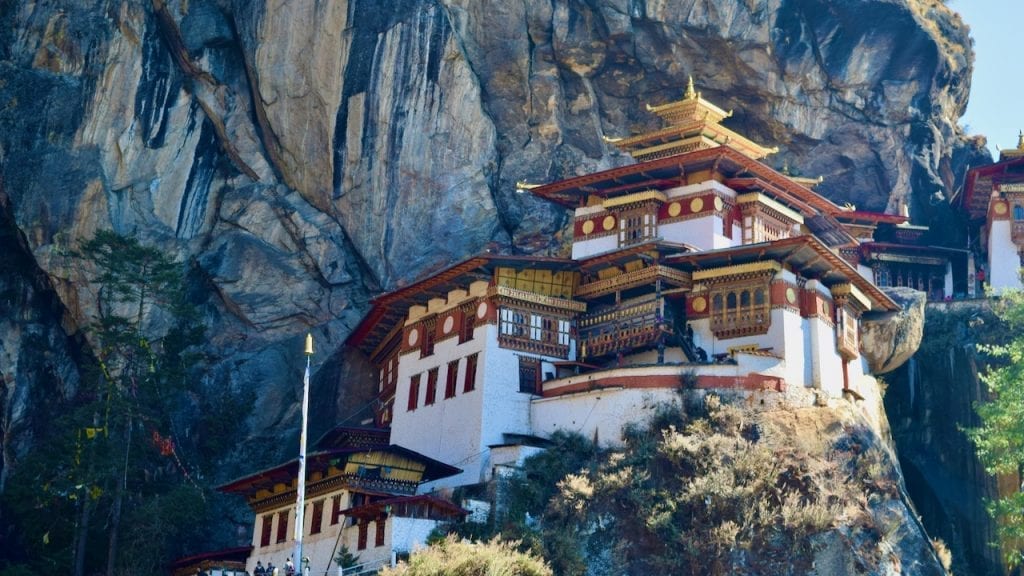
[[949, 0, 1024, 156]]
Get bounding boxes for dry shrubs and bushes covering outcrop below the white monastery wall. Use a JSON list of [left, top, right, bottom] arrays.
[[444, 396, 941, 575]]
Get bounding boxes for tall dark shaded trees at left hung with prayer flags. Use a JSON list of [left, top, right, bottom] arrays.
[[2, 231, 244, 574]]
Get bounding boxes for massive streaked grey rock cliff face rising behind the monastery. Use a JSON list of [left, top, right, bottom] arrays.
[[0, 0, 982, 565]]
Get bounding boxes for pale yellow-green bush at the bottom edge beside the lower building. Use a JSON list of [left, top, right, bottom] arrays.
[[380, 536, 552, 576]]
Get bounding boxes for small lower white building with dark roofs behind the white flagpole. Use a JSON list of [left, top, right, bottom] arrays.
[[216, 427, 466, 574]]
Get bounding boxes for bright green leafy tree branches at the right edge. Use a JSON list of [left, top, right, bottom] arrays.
[[966, 292, 1024, 566]]
